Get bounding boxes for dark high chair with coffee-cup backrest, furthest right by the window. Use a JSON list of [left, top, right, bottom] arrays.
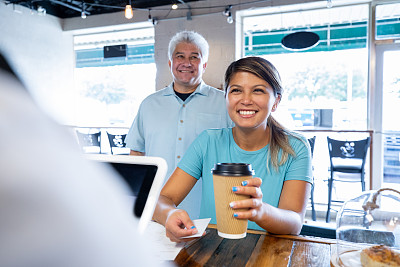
[[326, 137, 371, 222]]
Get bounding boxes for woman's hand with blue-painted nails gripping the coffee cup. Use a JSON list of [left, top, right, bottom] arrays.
[[230, 177, 263, 221]]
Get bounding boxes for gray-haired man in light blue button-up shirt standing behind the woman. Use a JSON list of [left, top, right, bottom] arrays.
[[125, 31, 233, 218]]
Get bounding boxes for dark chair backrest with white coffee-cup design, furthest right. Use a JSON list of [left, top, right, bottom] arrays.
[[327, 137, 371, 161]]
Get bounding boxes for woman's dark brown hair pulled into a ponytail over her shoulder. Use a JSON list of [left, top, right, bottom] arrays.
[[224, 57, 296, 169]]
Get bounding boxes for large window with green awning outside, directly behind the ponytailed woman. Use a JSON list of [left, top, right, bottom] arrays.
[[243, 5, 368, 130]]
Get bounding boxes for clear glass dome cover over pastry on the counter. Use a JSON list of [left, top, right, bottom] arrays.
[[333, 188, 400, 267]]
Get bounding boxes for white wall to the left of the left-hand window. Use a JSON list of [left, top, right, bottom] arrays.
[[0, 3, 75, 123]]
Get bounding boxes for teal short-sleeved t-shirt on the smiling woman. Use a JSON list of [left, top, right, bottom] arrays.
[[178, 128, 312, 230]]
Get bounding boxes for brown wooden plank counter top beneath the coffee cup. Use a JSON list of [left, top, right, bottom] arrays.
[[174, 226, 336, 267]]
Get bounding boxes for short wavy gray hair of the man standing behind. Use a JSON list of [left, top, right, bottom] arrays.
[[168, 31, 209, 62]]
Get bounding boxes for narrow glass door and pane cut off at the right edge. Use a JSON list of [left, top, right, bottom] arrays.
[[374, 3, 400, 190]]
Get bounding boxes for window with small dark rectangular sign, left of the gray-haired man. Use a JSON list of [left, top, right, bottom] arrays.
[[74, 27, 156, 128]]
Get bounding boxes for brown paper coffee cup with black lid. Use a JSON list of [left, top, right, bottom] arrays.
[[212, 163, 254, 239]]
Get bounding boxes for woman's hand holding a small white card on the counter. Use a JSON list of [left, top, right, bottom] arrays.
[[165, 209, 198, 243]]
